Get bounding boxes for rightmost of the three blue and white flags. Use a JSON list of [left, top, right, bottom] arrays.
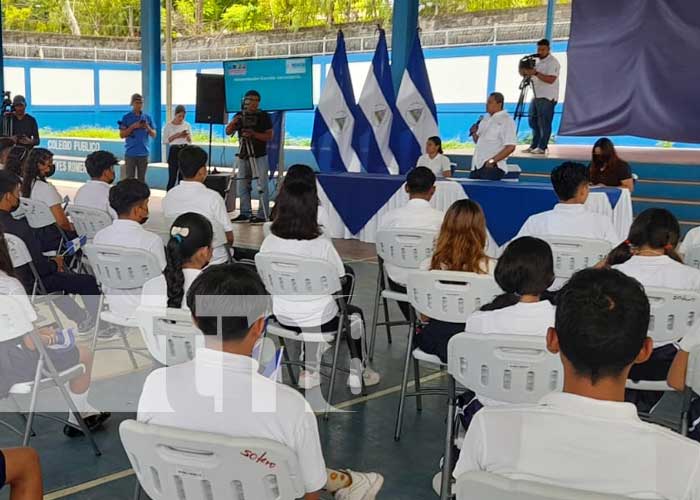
[[391, 31, 439, 174]]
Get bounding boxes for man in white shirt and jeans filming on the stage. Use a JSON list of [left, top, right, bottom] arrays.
[[523, 38, 561, 155]]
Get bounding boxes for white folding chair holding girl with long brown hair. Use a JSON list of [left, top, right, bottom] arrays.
[[394, 271, 501, 441]]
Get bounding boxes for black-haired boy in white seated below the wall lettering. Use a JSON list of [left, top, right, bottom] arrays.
[[73, 151, 119, 219]]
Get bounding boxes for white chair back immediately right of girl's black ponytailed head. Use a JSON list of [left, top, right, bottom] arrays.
[[542, 236, 612, 278]]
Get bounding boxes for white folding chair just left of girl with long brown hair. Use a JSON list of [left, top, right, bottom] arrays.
[[369, 228, 437, 360]]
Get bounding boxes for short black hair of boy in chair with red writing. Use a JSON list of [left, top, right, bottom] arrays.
[[187, 264, 270, 341]]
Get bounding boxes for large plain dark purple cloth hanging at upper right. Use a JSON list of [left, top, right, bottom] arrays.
[[559, 0, 700, 143]]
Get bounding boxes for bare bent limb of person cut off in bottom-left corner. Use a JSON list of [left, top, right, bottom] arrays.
[[0, 448, 44, 500]]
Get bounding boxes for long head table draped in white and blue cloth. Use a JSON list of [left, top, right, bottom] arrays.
[[318, 173, 632, 245]]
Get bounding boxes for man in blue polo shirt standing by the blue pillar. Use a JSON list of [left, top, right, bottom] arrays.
[[119, 94, 156, 182]]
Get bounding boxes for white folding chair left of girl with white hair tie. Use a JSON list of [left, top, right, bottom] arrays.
[[83, 244, 161, 368]]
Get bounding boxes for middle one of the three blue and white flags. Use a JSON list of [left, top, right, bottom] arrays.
[[354, 29, 399, 174]]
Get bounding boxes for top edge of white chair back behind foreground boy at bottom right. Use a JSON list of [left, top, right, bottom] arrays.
[[455, 472, 628, 500]]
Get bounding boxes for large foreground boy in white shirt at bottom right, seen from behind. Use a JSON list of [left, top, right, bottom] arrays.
[[454, 269, 700, 500]]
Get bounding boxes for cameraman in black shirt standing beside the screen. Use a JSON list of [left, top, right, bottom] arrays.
[[226, 90, 272, 224]]
